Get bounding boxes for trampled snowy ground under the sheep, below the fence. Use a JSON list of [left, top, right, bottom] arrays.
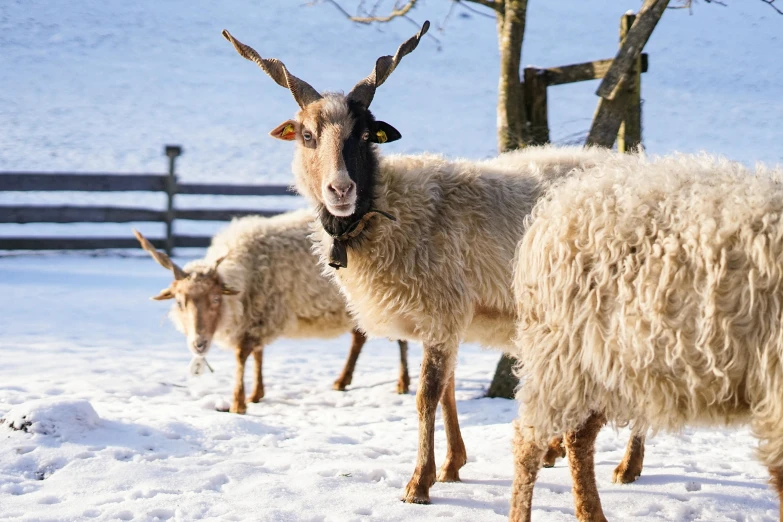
[[0, 255, 777, 522]]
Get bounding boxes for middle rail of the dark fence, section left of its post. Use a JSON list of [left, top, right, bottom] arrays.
[[0, 205, 166, 224]]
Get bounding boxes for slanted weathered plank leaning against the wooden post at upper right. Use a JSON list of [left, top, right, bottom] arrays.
[[596, 0, 669, 100]]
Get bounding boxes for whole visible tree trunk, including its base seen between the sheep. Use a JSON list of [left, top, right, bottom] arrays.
[[487, 0, 531, 399]]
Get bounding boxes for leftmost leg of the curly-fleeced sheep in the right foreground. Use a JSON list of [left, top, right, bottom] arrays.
[[508, 421, 545, 522]]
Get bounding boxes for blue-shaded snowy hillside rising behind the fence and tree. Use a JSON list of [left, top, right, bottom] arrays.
[[0, 0, 783, 183]]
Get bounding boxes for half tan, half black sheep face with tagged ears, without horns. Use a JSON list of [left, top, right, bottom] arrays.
[[270, 93, 401, 218]]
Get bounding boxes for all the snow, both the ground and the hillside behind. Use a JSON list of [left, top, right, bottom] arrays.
[[0, 0, 783, 522]]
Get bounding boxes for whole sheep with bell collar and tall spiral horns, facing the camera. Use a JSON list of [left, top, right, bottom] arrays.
[[223, 22, 644, 503]]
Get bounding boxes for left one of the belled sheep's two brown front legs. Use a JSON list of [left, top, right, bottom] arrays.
[[402, 343, 458, 504]]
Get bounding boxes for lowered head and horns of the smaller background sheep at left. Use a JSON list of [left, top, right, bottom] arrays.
[[133, 230, 239, 356]]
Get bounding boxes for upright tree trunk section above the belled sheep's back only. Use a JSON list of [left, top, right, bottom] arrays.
[[497, 0, 530, 152]]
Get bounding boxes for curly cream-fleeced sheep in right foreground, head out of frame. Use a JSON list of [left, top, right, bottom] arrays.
[[510, 155, 783, 521]]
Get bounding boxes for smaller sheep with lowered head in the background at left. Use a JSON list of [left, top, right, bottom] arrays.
[[134, 211, 410, 413]]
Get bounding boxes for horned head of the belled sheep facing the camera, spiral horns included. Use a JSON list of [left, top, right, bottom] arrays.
[[223, 22, 430, 254]]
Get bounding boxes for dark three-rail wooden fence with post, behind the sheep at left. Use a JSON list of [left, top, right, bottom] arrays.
[[0, 145, 296, 254]]
